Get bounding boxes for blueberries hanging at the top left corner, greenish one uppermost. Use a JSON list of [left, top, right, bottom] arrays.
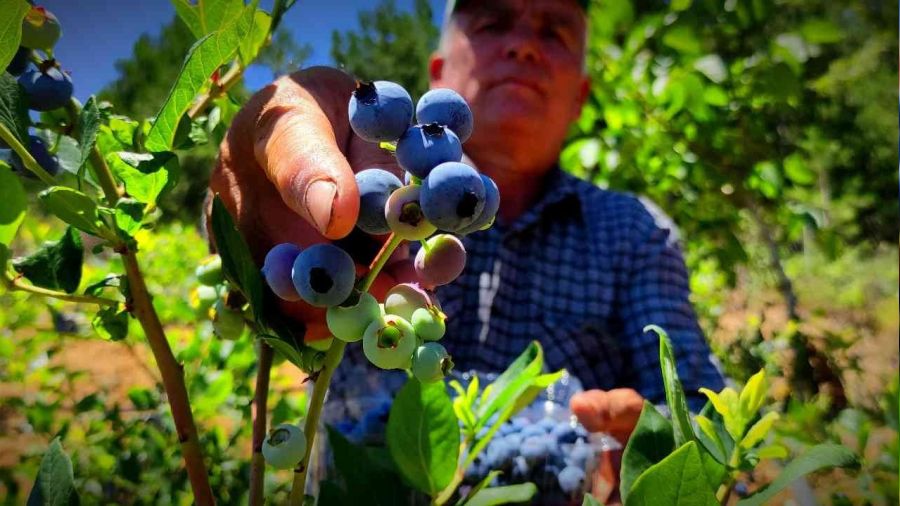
[[0, 6, 73, 177]]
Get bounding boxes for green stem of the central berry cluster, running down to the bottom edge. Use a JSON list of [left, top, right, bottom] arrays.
[[290, 234, 403, 506]]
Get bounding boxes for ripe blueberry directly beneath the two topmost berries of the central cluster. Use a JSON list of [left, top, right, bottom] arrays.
[[395, 123, 462, 178]]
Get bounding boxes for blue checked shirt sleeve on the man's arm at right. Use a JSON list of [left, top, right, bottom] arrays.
[[618, 200, 724, 412]]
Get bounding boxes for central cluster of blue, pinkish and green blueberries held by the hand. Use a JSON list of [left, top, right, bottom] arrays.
[[262, 81, 500, 382]]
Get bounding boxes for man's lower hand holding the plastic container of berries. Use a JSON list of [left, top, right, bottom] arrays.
[[569, 388, 644, 445]]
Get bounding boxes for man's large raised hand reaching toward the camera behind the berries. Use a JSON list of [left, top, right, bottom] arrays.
[[207, 67, 412, 341]]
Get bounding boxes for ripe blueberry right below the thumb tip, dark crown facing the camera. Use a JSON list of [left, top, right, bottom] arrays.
[[291, 244, 356, 307]]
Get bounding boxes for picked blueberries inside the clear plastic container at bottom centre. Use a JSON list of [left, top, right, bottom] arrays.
[[464, 416, 594, 504]]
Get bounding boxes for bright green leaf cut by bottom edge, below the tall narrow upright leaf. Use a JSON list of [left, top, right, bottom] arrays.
[[627, 441, 719, 506]]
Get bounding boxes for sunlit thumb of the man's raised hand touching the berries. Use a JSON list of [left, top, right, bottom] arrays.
[[253, 71, 359, 239]]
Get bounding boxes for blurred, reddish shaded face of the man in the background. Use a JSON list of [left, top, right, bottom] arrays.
[[430, 0, 589, 171]]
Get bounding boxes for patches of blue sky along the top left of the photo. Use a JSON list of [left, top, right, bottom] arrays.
[[35, 0, 444, 102]]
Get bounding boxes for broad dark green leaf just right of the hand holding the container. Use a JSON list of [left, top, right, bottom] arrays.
[[619, 400, 675, 501]]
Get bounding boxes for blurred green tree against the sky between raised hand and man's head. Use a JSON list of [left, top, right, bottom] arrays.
[[331, 0, 439, 100]]
